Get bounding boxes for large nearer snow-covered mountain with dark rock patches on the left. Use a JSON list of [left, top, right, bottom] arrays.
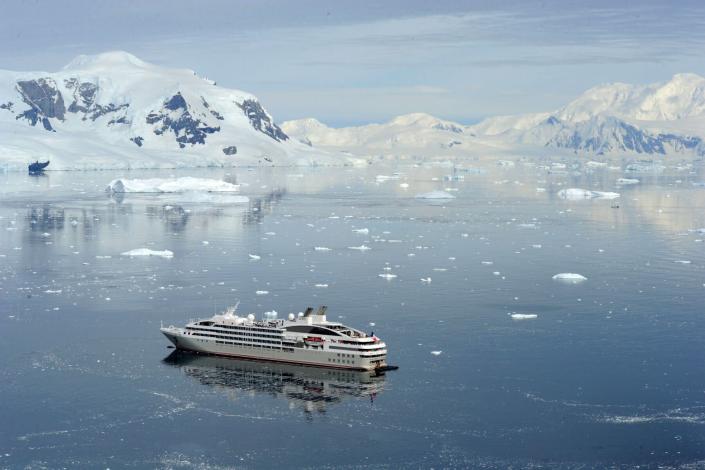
[[0, 52, 334, 169]]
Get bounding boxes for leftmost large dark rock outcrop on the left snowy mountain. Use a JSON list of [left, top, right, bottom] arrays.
[[16, 78, 66, 131]]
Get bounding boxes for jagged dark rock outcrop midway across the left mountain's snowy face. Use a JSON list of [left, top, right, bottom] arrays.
[[146, 93, 220, 148]]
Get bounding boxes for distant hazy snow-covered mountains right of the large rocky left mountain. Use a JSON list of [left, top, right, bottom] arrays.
[[282, 74, 705, 157]]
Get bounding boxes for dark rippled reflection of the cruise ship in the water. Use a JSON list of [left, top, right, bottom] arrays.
[[164, 350, 385, 413]]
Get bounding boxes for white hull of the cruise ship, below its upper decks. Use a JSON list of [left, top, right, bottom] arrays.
[[161, 327, 387, 371]]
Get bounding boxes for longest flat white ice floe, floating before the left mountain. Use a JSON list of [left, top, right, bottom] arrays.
[[105, 176, 240, 193]]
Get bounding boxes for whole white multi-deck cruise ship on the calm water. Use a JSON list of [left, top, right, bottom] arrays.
[[161, 306, 388, 370]]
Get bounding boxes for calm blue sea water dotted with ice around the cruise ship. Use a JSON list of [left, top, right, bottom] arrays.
[[0, 164, 705, 468]]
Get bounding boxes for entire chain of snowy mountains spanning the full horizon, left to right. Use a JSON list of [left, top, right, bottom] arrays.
[[0, 51, 705, 169]]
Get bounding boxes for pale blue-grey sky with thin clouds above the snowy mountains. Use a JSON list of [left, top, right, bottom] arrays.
[[0, 0, 705, 126]]
